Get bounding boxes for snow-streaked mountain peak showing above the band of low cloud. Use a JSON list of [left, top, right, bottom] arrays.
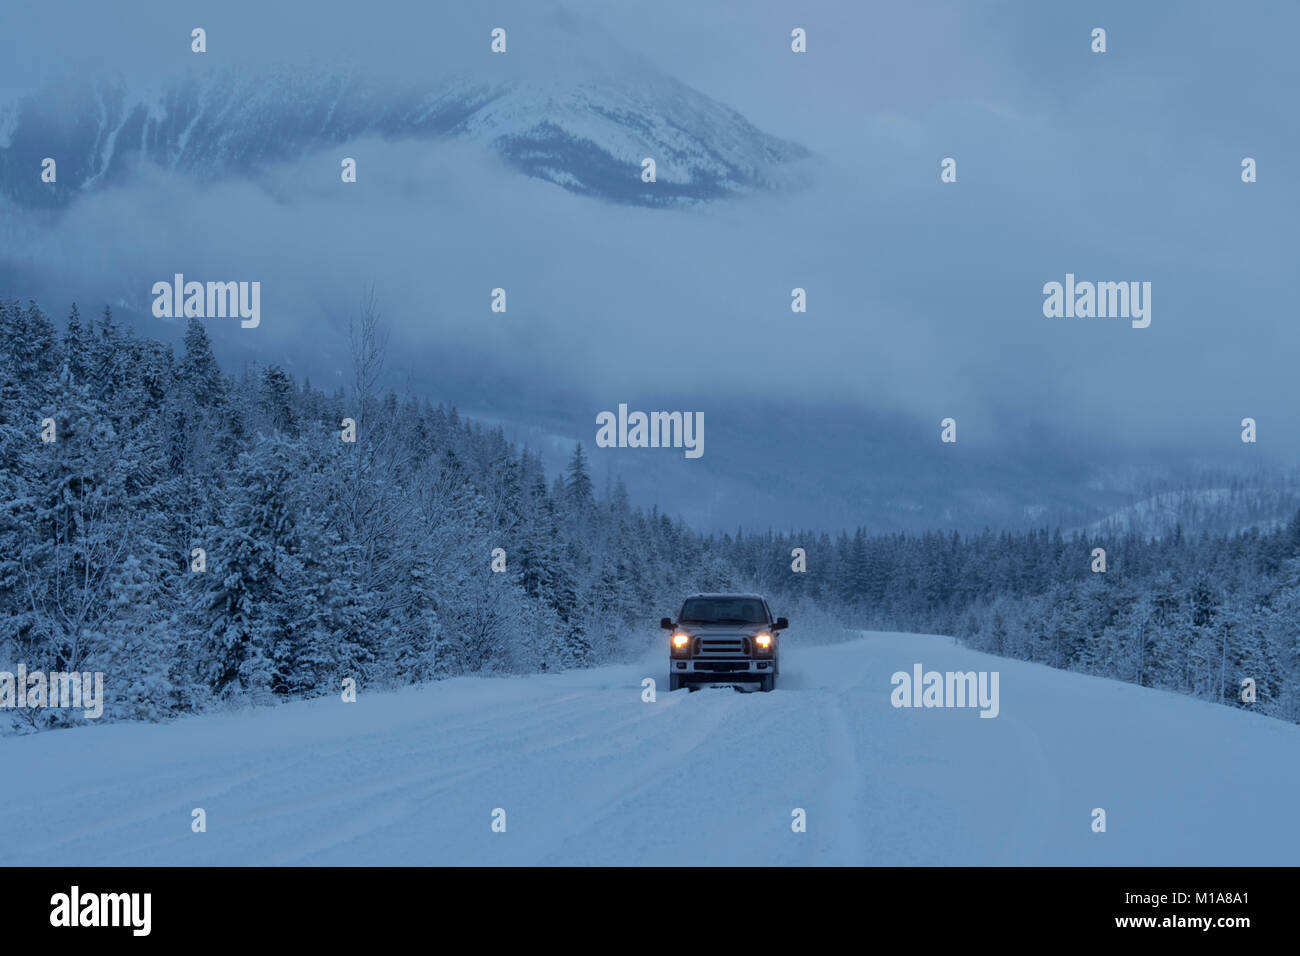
[[0, 65, 806, 207]]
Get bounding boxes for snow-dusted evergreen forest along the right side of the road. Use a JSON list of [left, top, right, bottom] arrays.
[[743, 514, 1300, 722]]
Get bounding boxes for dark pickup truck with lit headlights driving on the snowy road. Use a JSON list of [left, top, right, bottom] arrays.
[[659, 594, 790, 691]]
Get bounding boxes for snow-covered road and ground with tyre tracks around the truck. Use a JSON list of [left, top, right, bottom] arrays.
[[0, 632, 1300, 865]]
